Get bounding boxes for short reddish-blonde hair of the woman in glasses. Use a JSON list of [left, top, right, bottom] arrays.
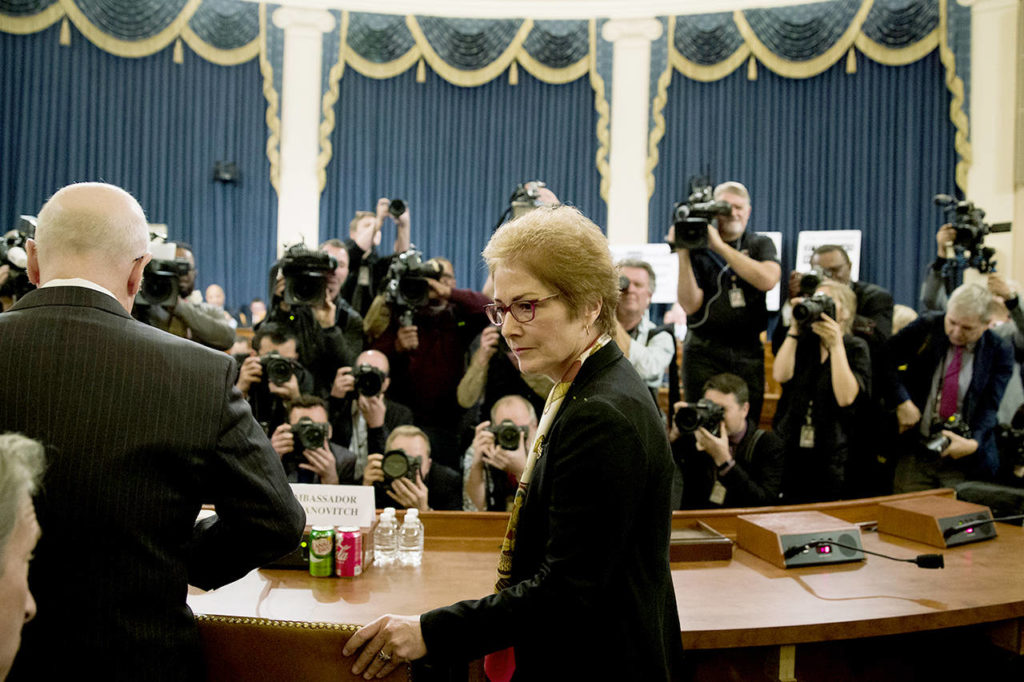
[[483, 206, 618, 334]]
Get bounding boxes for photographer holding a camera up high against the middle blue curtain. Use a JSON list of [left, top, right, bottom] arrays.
[[341, 197, 413, 317]]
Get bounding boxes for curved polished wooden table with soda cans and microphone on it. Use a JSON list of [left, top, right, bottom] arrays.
[[188, 489, 1024, 680]]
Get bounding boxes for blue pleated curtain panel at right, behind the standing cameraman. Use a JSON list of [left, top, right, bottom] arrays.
[[649, 52, 956, 307]]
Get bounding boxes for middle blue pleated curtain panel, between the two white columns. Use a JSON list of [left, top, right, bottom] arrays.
[[321, 70, 606, 289]]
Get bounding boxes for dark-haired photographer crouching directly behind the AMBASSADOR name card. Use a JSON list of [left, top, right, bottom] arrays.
[[270, 395, 357, 485]]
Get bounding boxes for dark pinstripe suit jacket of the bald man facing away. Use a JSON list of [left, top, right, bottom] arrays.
[[0, 287, 305, 682]]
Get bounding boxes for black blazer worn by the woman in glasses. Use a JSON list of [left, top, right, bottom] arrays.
[[420, 343, 682, 681]]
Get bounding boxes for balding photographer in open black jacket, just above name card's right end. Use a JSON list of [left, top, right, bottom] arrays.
[[330, 350, 413, 478]]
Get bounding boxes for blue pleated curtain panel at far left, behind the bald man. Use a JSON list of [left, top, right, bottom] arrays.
[[0, 26, 278, 307]]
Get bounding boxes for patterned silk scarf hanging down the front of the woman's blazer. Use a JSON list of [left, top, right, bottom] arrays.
[[483, 334, 611, 682]]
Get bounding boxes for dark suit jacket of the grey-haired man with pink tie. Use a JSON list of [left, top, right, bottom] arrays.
[[889, 312, 1014, 477]]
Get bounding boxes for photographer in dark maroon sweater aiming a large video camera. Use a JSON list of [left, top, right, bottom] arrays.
[[367, 254, 490, 469]]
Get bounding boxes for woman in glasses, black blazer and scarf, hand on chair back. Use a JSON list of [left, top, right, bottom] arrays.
[[344, 207, 682, 680]]
